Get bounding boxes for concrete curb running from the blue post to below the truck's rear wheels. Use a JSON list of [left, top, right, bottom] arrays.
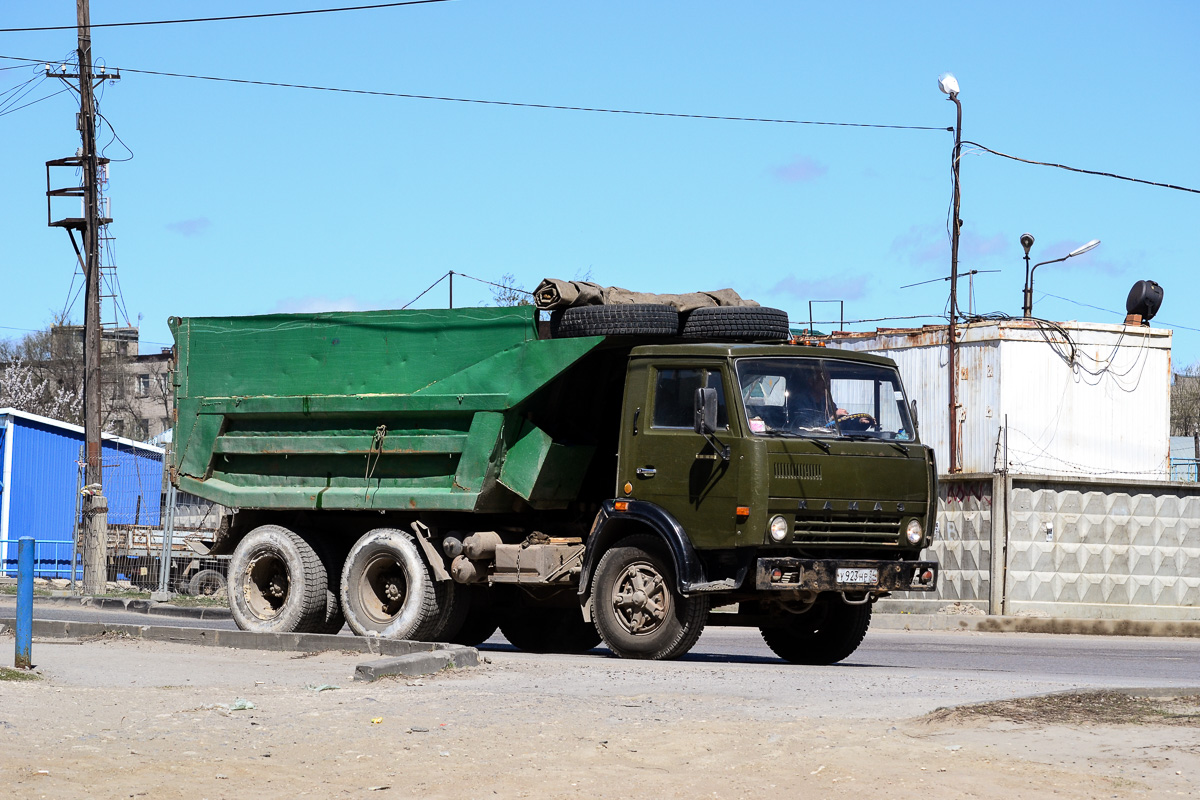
[[0, 618, 479, 676]]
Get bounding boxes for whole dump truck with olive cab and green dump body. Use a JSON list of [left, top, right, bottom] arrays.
[[170, 307, 937, 663]]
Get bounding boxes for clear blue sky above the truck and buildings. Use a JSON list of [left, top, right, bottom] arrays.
[[0, 0, 1200, 367]]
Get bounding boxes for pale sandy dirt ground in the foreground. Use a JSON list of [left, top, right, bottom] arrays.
[[0, 637, 1200, 800]]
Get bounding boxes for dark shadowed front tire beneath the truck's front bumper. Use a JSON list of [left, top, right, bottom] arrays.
[[758, 595, 871, 664]]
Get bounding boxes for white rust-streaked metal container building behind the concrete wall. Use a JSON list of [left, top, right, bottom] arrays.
[[829, 319, 1171, 480]]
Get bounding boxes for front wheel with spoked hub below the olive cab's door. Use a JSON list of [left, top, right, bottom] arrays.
[[592, 535, 709, 660]]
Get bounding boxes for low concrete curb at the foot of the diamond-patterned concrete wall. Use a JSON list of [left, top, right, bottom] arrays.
[[871, 614, 1200, 638]]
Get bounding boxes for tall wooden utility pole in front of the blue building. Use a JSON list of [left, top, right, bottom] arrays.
[[46, 0, 121, 594]]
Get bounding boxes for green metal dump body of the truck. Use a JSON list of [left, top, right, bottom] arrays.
[[169, 307, 612, 511]]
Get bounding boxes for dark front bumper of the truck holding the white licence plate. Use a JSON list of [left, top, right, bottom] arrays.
[[755, 558, 938, 591]]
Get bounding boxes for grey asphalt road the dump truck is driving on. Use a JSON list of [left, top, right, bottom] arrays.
[[0, 597, 1200, 687]]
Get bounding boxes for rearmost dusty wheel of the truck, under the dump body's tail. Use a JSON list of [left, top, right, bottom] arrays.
[[228, 525, 329, 633]]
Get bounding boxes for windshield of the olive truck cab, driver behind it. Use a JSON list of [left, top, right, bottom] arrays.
[[737, 359, 916, 441]]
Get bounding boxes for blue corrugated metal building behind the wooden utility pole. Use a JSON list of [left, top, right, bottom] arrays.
[[0, 408, 163, 578]]
